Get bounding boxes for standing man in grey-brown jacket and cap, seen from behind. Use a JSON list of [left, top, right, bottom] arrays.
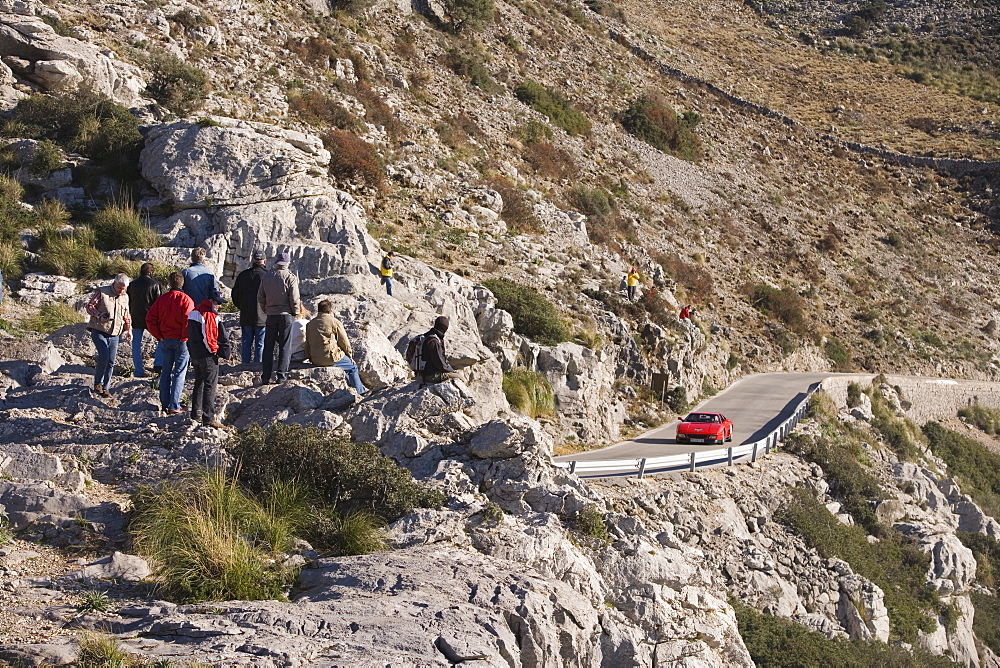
[[257, 253, 300, 385]]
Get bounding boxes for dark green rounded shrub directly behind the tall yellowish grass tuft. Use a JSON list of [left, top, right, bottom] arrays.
[[229, 423, 444, 522]]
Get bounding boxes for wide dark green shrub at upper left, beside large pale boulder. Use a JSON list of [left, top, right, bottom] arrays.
[[2, 88, 142, 180]]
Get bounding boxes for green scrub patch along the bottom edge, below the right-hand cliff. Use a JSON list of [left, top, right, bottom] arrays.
[[730, 600, 955, 668]]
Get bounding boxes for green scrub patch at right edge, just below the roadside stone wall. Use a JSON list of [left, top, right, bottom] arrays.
[[923, 422, 1000, 517]]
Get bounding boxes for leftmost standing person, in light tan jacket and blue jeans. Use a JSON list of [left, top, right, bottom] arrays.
[[87, 274, 132, 397]]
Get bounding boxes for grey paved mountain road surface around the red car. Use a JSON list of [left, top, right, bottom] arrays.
[[556, 373, 834, 462]]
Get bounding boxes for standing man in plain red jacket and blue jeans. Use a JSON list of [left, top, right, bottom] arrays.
[[146, 271, 194, 415]]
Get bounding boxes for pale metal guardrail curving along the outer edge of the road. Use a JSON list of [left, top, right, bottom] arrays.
[[557, 383, 823, 478]]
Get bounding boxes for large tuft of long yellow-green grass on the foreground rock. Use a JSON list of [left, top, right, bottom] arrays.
[[129, 469, 306, 602]]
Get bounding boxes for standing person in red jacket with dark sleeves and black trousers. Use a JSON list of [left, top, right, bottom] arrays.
[[188, 290, 232, 429]]
